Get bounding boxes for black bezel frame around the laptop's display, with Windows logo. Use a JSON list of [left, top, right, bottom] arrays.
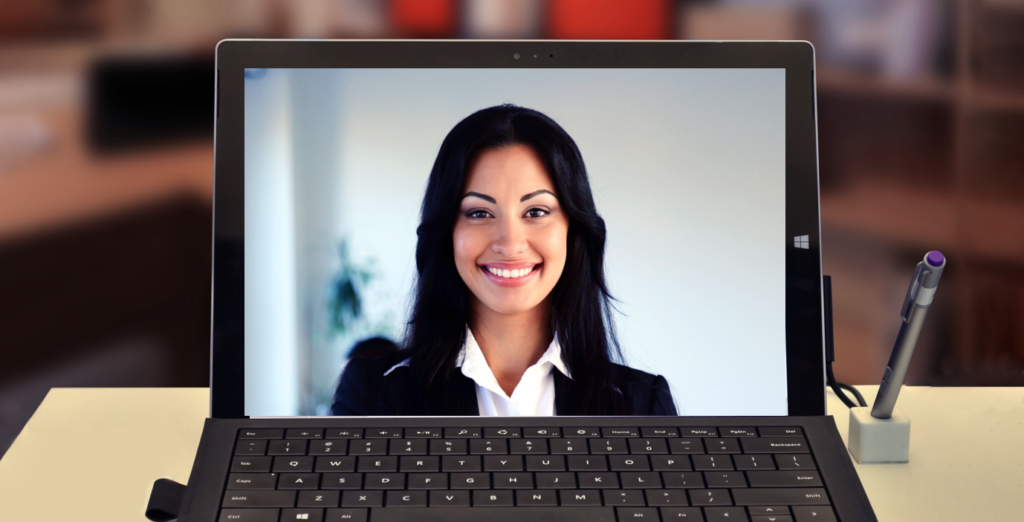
[[210, 40, 825, 419]]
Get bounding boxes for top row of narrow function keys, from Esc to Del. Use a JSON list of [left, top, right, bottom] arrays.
[[239, 426, 804, 440]]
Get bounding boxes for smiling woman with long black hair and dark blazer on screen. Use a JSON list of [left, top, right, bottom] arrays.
[[331, 105, 676, 416]]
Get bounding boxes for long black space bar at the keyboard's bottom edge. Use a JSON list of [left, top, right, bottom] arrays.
[[370, 506, 615, 522]]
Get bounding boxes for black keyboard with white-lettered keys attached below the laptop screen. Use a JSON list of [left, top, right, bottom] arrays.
[[179, 417, 876, 522]]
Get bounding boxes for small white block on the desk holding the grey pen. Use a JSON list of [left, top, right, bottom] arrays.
[[848, 407, 910, 464]]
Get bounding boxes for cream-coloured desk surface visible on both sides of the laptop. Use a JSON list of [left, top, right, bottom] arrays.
[[0, 386, 1024, 522]]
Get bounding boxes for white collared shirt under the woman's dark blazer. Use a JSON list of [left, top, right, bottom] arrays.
[[384, 328, 570, 417]]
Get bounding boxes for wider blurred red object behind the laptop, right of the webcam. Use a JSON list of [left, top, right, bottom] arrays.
[[548, 0, 672, 40]]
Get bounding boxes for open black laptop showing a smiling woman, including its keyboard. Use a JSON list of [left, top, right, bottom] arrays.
[[167, 40, 876, 522]]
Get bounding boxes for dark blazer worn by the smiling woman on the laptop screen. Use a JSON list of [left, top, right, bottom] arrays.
[[331, 353, 678, 416]]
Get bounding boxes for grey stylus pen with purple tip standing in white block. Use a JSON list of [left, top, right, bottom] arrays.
[[871, 250, 946, 419]]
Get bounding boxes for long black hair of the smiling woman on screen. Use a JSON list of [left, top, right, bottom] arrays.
[[406, 104, 632, 415]]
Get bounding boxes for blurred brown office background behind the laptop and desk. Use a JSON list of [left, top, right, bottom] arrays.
[[0, 0, 1024, 454]]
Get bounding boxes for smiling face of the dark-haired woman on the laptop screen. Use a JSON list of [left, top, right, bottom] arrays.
[[453, 144, 569, 314]]
